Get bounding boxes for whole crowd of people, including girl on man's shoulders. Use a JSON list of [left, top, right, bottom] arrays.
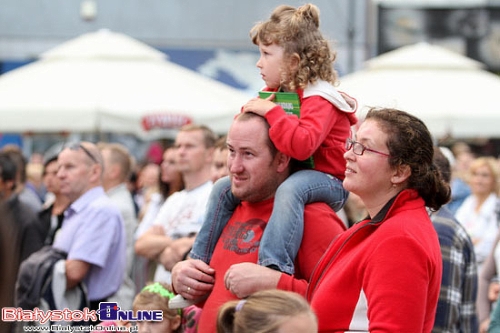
[[0, 4, 500, 333]]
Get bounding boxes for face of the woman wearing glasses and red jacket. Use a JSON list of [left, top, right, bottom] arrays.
[[344, 119, 395, 206]]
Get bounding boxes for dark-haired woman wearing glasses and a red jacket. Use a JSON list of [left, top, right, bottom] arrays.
[[307, 109, 450, 333]]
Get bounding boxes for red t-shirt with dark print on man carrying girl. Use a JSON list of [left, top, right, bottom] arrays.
[[198, 198, 345, 333]]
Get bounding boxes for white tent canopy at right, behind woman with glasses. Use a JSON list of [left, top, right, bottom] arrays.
[[339, 43, 500, 138]]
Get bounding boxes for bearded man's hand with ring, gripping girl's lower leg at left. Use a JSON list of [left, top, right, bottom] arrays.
[[172, 259, 215, 299]]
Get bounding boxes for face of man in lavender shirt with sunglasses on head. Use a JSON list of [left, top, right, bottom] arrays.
[[57, 148, 100, 201]]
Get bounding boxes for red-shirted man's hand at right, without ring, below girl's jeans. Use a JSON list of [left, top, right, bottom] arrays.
[[224, 262, 282, 298]]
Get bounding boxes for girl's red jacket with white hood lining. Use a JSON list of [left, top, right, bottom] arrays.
[[266, 81, 357, 180]]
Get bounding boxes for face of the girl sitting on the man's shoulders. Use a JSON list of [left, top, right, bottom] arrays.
[[256, 44, 284, 89]]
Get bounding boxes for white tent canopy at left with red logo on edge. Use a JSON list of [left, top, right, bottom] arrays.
[[0, 30, 249, 138]]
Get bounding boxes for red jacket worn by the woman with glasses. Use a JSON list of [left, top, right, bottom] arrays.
[[307, 190, 442, 333]]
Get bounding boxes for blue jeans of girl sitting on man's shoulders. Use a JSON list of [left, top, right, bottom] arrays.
[[190, 170, 348, 274]]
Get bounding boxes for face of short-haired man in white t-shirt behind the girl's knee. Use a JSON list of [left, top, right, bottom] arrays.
[[175, 130, 213, 174]]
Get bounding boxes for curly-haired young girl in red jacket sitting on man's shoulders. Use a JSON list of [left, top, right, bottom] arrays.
[[190, 4, 357, 280]]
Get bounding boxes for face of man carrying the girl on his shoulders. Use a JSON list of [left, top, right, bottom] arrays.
[[227, 118, 283, 202]]
